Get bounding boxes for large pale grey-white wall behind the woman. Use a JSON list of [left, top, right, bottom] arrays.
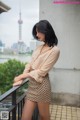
[[39, 0, 80, 95]]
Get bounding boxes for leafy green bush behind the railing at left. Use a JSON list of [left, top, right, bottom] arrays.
[[0, 59, 25, 94]]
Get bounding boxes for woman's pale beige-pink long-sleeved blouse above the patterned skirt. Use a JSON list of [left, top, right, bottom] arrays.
[[24, 45, 60, 83]]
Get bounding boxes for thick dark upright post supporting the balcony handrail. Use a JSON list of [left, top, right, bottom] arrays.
[[12, 91, 16, 120]]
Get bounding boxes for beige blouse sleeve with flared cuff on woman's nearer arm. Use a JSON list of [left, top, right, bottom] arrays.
[[29, 49, 60, 83]]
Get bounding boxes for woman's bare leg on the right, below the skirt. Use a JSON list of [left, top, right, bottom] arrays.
[[38, 102, 50, 120]]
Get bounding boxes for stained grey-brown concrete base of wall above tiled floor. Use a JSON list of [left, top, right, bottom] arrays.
[[52, 93, 80, 107]]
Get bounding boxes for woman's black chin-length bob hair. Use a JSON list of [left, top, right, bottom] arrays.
[[32, 20, 58, 47]]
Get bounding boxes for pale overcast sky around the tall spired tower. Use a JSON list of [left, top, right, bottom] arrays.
[[0, 0, 39, 46]]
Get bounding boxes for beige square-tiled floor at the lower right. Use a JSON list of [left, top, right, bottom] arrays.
[[50, 104, 80, 120]]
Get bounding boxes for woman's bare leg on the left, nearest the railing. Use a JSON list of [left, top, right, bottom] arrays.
[[21, 100, 36, 120]]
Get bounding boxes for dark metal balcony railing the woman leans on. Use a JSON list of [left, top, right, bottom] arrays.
[[0, 80, 38, 120]]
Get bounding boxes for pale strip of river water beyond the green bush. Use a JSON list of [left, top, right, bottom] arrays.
[[0, 54, 31, 63]]
